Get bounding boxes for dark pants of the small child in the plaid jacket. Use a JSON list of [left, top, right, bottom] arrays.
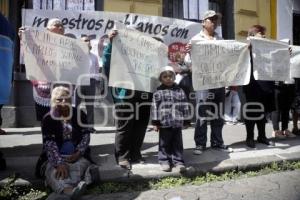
[[158, 128, 184, 166]]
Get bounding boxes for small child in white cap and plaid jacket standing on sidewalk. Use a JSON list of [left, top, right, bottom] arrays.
[[152, 66, 189, 172]]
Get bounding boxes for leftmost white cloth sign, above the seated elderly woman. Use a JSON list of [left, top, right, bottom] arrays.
[[22, 29, 89, 85]]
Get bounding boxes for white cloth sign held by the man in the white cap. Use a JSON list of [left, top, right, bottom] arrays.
[[191, 40, 251, 90]]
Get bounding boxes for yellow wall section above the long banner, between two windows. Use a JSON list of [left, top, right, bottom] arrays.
[[104, 0, 163, 16]]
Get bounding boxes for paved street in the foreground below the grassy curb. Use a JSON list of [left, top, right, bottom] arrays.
[[81, 170, 300, 200]]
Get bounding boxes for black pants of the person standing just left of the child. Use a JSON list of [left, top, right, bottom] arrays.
[[115, 96, 151, 163]]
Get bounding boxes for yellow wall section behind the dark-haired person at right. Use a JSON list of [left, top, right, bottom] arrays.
[[234, 0, 276, 39]]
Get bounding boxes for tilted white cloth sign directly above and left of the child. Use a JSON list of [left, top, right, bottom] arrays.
[[109, 24, 168, 92]]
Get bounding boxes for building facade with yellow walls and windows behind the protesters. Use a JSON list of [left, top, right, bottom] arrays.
[[0, 0, 300, 127]]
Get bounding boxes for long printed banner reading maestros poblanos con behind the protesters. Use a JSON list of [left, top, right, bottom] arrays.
[[22, 9, 201, 57]]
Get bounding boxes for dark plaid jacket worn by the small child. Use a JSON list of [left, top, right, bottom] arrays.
[[152, 84, 189, 128]]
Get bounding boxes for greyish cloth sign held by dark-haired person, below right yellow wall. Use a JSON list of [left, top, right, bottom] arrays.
[[250, 37, 290, 81]]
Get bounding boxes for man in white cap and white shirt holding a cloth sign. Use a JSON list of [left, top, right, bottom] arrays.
[[185, 10, 228, 155]]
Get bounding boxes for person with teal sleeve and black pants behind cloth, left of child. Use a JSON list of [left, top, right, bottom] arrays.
[[103, 30, 152, 170]]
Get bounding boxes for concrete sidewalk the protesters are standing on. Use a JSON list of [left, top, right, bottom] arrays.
[[0, 124, 300, 184]]
